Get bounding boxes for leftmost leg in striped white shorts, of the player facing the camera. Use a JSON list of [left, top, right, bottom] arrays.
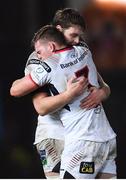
[[36, 138, 64, 178]]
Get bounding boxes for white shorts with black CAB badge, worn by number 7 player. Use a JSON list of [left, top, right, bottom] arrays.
[[60, 139, 116, 179]]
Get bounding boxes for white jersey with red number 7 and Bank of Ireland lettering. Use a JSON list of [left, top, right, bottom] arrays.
[[30, 46, 116, 143]]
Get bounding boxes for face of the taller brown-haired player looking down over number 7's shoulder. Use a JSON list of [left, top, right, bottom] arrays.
[[62, 25, 84, 45]]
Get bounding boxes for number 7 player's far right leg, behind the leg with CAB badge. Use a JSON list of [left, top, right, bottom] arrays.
[[96, 139, 117, 179]]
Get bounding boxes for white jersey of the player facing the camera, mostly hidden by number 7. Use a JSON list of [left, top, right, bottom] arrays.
[[25, 52, 64, 144]]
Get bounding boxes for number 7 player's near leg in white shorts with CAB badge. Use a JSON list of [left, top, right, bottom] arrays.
[[60, 140, 115, 179]]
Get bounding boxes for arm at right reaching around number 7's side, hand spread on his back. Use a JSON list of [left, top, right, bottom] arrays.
[[80, 73, 111, 109]]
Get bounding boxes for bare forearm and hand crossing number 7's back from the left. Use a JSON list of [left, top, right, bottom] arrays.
[[33, 77, 88, 116]]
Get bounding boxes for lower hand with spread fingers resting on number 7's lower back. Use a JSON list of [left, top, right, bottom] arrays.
[[80, 87, 104, 109]]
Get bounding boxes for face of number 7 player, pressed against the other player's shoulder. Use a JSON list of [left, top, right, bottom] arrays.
[[35, 40, 52, 59]]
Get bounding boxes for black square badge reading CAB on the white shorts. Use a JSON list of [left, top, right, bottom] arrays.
[[79, 162, 94, 174]]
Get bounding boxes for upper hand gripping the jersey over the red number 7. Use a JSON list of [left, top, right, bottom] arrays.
[[67, 76, 89, 97]]
